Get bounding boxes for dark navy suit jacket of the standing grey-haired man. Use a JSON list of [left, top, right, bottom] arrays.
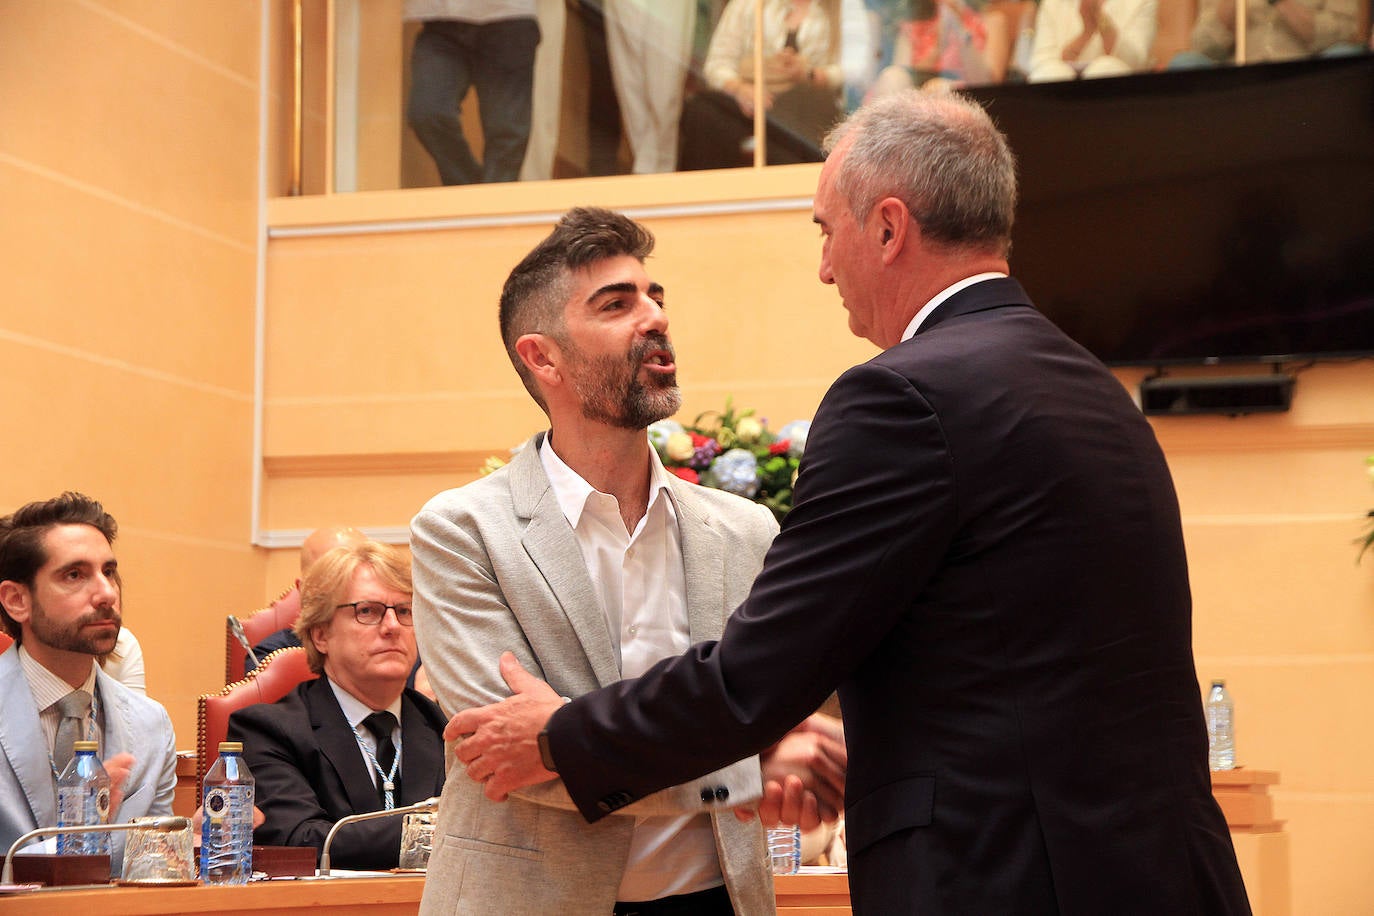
[[550, 279, 1249, 916]]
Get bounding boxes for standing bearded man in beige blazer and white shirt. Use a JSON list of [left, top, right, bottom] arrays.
[[411, 210, 844, 916]]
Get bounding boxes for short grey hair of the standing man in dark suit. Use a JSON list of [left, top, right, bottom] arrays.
[[824, 91, 1017, 257]]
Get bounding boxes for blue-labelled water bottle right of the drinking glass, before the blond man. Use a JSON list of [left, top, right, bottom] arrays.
[[201, 742, 253, 884]]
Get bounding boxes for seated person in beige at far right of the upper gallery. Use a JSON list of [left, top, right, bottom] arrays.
[[1169, 0, 1360, 69]]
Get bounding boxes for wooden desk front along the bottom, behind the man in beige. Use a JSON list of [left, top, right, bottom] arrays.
[[0, 875, 849, 916]]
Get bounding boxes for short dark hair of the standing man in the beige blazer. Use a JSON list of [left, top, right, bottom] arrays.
[[500, 207, 654, 413]]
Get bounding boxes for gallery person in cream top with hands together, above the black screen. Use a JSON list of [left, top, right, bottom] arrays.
[[1026, 0, 1158, 82]]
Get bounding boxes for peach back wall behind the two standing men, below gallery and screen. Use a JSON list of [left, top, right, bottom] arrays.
[[264, 173, 1374, 916]]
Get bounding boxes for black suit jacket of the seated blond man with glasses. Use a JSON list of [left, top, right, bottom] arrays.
[[228, 676, 447, 869]]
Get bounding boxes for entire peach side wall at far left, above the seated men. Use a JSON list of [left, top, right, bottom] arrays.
[[0, 0, 265, 747]]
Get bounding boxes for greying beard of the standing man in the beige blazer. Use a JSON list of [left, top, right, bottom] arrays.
[[565, 334, 683, 430]]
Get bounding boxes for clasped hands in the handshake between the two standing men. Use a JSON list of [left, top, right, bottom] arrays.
[[735, 713, 849, 829]]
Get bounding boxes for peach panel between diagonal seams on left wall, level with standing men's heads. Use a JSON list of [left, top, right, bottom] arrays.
[[0, 162, 256, 397]]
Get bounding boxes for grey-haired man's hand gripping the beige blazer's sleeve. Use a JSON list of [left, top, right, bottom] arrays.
[[444, 652, 563, 802]]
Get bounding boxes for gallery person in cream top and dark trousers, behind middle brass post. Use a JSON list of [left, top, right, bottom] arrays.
[[677, 0, 844, 170]]
